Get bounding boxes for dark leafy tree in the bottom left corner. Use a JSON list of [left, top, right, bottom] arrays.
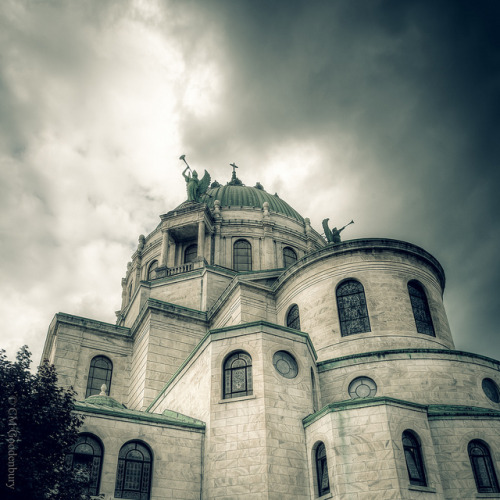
[[0, 346, 90, 500]]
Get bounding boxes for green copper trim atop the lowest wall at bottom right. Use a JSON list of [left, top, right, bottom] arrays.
[[302, 397, 500, 428]]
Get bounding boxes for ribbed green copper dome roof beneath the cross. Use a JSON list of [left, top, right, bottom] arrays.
[[200, 184, 304, 222]]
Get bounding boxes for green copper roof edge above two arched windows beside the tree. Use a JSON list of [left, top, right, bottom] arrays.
[[75, 401, 205, 430]]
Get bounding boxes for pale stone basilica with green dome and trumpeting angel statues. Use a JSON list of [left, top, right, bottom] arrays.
[[43, 166, 500, 500]]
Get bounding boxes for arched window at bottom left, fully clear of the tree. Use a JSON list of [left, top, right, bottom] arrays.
[[115, 441, 152, 500]]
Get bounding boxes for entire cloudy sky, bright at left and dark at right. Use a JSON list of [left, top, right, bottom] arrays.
[[0, 0, 500, 368]]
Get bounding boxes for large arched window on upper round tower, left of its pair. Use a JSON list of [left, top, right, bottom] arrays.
[[337, 280, 371, 337]]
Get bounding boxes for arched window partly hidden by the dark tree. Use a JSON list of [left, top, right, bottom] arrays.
[[66, 434, 103, 495]]
